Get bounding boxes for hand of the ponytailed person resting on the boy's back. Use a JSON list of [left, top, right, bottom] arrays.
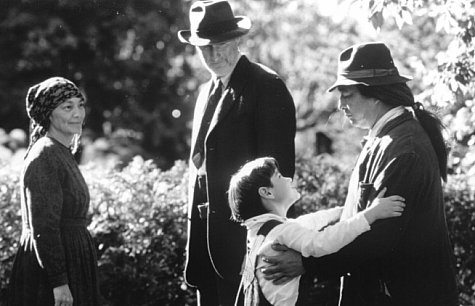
[[260, 243, 305, 285]]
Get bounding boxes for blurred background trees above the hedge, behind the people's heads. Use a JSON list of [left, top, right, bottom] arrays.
[[0, 0, 475, 177]]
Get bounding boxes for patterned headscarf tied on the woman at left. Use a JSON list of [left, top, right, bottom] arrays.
[[26, 77, 86, 153]]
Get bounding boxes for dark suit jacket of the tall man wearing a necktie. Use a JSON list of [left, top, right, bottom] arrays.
[[185, 56, 296, 286]]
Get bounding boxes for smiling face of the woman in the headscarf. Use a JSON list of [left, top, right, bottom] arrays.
[[48, 97, 86, 138]]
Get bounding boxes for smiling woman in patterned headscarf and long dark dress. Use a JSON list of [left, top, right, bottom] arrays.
[[9, 77, 99, 306]]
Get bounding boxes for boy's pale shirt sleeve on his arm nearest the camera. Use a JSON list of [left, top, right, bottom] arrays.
[[274, 213, 370, 257]]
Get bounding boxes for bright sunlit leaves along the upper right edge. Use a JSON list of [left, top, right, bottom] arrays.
[[356, 0, 475, 184]]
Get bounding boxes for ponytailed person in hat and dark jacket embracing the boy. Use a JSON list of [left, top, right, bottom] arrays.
[[260, 42, 458, 306]]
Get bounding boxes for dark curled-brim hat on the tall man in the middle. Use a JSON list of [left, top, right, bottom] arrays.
[[178, 0, 251, 46]]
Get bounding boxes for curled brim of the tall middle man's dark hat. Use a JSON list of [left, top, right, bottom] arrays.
[[178, 16, 251, 46]]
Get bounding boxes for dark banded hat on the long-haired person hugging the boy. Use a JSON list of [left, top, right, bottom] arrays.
[[328, 42, 412, 91]]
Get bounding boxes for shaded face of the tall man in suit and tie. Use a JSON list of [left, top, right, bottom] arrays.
[[197, 39, 239, 77]]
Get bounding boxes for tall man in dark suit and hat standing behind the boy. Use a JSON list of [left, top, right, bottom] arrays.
[[178, 1, 296, 306]]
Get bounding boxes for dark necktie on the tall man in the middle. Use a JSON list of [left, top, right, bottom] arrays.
[[192, 80, 223, 169]]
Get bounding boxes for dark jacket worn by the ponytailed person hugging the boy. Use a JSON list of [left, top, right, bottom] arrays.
[[304, 112, 458, 306]]
